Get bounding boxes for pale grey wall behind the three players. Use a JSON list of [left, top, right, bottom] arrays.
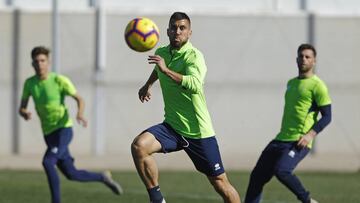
[[0, 9, 360, 170]]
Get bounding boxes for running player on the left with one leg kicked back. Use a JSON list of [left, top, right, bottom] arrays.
[[19, 46, 122, 203]]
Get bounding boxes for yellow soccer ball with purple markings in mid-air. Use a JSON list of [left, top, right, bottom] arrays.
[[125, 18, 159, 52]]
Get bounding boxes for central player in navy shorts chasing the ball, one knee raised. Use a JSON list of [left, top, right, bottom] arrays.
[[131, 12, 240, 203]]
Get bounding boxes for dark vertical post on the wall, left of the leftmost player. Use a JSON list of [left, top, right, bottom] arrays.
[[11, 9, 20, 154]]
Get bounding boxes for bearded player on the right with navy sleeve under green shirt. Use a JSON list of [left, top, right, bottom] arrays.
[[245, 44, 331, 203]]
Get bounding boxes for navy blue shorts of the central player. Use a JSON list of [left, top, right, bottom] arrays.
[[145, 123, 225, 177]]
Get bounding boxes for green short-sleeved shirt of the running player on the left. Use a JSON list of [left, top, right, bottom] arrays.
[[21, 73, 76, 136]]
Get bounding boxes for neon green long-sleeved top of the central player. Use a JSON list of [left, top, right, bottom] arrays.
[[155, 42, 215, 139]]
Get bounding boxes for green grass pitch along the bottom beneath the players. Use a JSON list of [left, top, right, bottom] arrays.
[[0, 170, 360, 203]]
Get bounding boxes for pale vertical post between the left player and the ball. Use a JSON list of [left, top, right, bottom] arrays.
[[92, 0, 106, 155]]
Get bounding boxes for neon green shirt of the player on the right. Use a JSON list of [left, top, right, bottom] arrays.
[[275, 75, 331, 147]]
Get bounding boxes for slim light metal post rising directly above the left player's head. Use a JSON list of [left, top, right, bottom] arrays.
[[52, 0, 60, 73]]
